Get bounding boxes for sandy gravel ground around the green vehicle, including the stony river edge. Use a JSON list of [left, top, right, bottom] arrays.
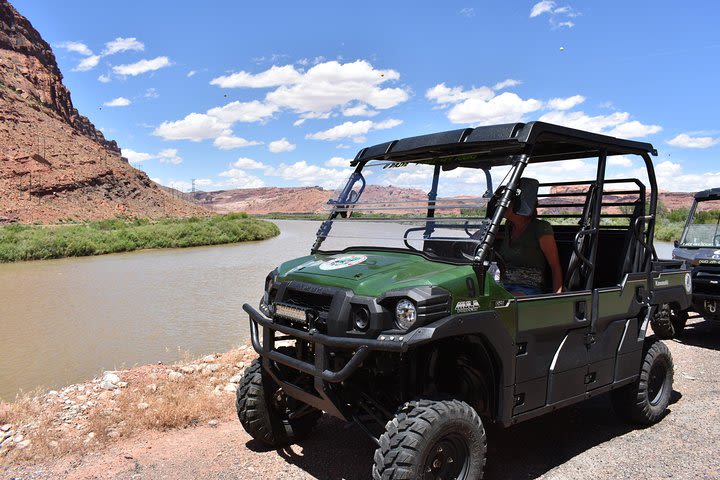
[[0, 319, 720, 480]]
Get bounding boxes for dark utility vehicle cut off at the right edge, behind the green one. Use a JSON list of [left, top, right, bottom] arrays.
[[664, 188, 720, 338]]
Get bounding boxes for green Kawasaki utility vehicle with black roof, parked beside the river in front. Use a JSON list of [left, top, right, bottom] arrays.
[[237, 122, 691, 479]]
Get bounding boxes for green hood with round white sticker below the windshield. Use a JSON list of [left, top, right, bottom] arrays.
[[278, 250, 475, 296]]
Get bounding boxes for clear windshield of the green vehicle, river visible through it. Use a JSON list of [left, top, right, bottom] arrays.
[[316, 161, 500, 261]]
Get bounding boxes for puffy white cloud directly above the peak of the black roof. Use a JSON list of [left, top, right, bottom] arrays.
[[448, 92, 543, 125]]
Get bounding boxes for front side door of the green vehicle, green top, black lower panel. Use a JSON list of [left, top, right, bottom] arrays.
[[513, 292, 592, 414]]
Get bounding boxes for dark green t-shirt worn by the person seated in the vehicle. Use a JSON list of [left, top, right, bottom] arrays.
[[500, 218, 553, 292]]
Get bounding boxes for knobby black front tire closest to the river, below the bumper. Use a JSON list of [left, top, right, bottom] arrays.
[[235, 358, 322, 448]]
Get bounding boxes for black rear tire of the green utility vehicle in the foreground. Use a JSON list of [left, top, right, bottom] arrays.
[[612, 340, 673, 425]]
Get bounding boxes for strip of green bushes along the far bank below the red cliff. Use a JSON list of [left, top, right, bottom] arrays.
[[0, 213, 280, 262]]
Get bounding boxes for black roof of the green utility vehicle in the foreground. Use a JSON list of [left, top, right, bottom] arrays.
[[352, 122, 657, 167]]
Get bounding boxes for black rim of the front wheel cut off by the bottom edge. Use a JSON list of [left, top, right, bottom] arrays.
[[423, 433, 470, 480]]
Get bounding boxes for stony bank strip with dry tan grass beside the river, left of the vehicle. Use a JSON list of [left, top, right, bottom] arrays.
[[0, 345, 257, 465]]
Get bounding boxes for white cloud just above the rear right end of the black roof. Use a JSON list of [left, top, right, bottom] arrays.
[[540, 111, 662, 138]]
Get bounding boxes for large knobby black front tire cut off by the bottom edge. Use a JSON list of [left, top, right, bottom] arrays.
[[373, 400, 487, 480]]
